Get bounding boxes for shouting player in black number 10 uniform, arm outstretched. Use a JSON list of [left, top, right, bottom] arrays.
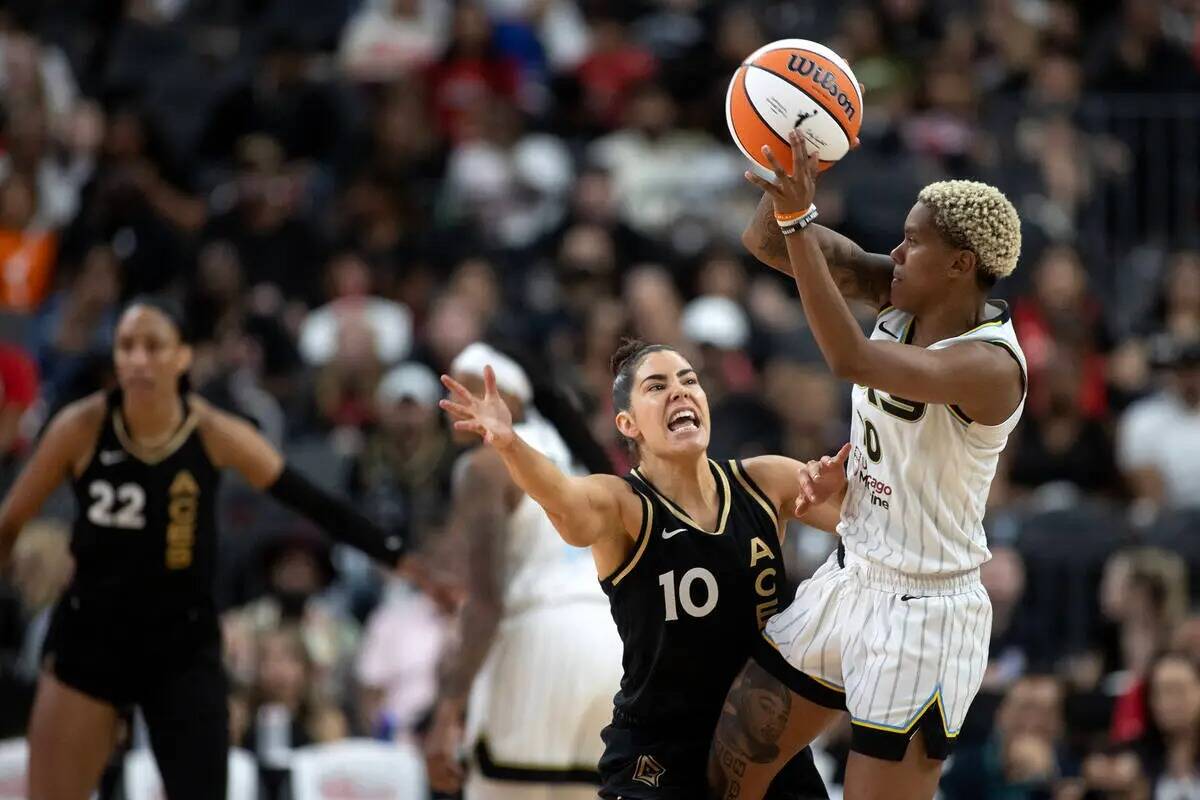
[[443, 342, 846, 800]]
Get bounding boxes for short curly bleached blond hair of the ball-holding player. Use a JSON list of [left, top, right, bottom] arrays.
[[917, 181, 1021, 282]]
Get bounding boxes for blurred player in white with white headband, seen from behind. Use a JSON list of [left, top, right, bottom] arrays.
[[427, 343, 622, 800]]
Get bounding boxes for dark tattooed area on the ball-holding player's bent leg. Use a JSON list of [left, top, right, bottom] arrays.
[[708, 661, 792, 800]]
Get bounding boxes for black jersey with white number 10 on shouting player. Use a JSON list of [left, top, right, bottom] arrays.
[[601, 461, 786, 732]]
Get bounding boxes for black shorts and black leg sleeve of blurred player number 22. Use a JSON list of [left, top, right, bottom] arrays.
[[43, 593, 229, 800]]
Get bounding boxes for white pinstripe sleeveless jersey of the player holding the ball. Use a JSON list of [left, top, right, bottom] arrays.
[[838, 301, 1026, 575]]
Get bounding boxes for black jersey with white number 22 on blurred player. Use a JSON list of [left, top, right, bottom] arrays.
[[71, 391, 220, 621]]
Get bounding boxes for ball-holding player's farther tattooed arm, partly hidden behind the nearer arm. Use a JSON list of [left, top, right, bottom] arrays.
[[742, 193, 893, 308]]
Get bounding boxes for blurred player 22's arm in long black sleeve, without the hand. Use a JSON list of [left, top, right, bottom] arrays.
[[200, 404, 403, 567]]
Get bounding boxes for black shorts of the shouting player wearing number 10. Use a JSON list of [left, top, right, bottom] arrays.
[[600, 726, 829, 800]]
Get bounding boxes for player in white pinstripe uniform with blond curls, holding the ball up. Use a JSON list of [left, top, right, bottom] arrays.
[[709, 131, 1026, 800]]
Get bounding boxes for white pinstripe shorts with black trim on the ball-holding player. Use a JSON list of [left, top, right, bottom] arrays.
[[755, 548, 991, 760]]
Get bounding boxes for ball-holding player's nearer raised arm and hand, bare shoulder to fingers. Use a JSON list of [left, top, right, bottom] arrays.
[[746, 136, 1022, 425]]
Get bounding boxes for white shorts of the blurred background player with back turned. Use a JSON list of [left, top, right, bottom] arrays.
[[466, 597, 622, 786]]
